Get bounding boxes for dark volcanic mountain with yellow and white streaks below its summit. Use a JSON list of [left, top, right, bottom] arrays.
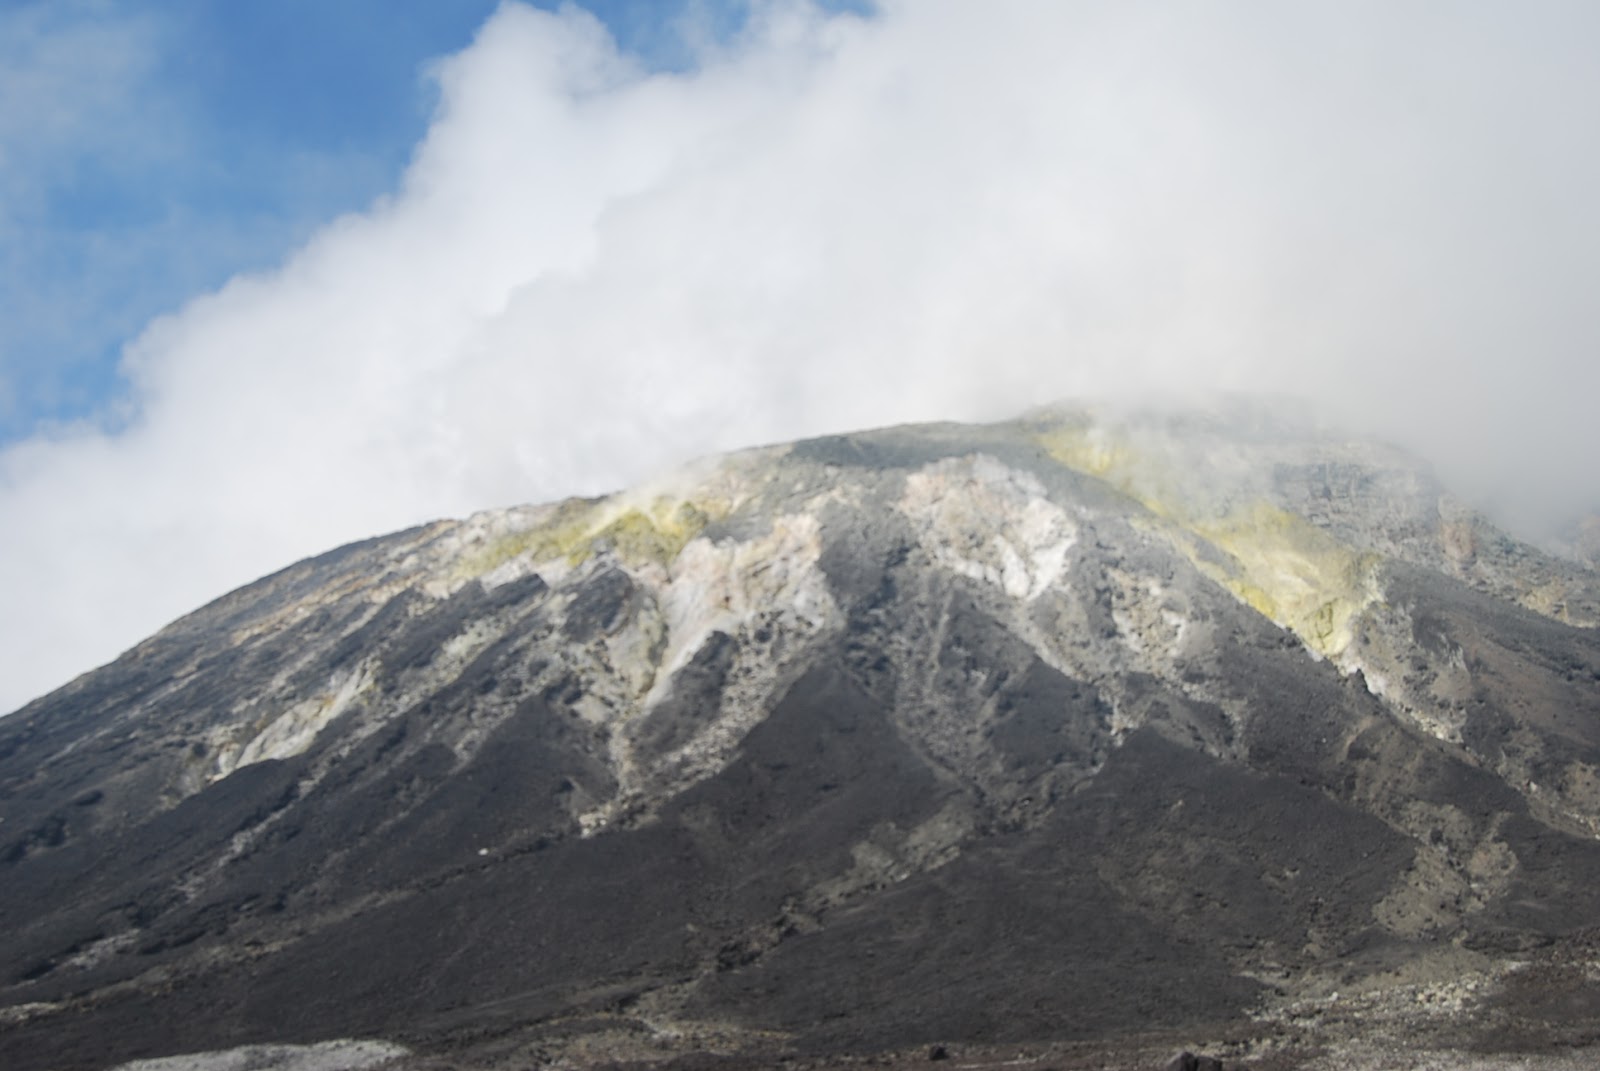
[[0, 407, 1600, 1071]]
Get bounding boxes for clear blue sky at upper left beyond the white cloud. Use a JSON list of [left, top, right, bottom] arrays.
[[0, 0, 861, 445]]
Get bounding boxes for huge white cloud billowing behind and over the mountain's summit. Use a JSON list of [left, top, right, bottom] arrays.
[[0, 0, 1600, 708]]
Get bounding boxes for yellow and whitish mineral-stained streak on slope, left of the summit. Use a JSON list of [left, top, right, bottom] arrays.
[[435, 448, 842, 834]]
